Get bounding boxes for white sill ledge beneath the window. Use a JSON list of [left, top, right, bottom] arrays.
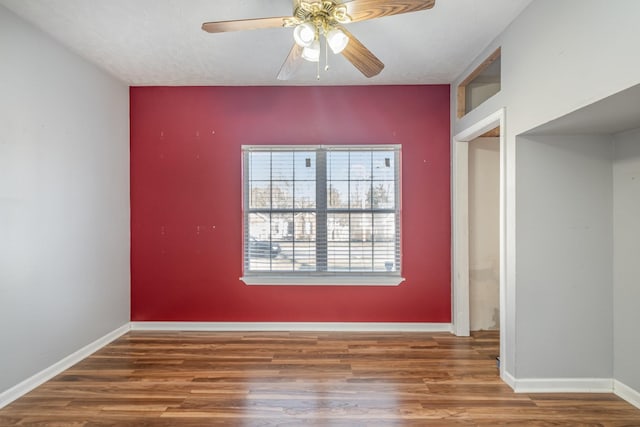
[[240, 275, 404, 286]]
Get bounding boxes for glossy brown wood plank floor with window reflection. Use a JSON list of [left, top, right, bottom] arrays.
[[0, 332, 640, 427]]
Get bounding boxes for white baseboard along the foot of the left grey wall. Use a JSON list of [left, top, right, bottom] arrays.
[[0, 323, 130, 408]]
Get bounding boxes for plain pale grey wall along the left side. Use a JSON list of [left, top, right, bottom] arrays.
[[0, 6, 130, 393]]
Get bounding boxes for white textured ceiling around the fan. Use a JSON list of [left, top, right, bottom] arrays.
[[0, 0, 532, 86]]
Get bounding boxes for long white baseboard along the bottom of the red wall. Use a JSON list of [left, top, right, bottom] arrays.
[[131, 322, 451, 333]]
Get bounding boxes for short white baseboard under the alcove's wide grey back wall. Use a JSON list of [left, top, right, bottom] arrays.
[[513, 378, 613, 393]]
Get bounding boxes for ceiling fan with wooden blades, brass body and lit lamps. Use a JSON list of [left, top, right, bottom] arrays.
[[202, 0, 435, 80]]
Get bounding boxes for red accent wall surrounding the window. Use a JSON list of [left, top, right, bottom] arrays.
[[131, 85, 451, 322]]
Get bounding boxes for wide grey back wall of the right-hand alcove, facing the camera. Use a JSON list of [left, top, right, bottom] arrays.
[[516, 135, 613, 379]]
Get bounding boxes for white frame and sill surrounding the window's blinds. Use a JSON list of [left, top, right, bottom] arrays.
[[240, 144, 405, 286]]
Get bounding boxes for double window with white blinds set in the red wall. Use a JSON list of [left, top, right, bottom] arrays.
[[242, 145, 402, 285]]
